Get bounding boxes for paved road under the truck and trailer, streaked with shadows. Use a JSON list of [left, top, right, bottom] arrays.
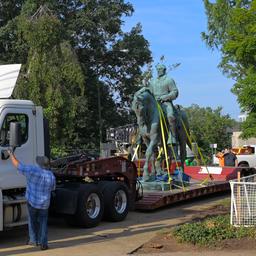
[[0, 196, 255, 256]]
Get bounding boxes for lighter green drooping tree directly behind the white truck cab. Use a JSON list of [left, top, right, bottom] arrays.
[[15, 3, 85, 152]]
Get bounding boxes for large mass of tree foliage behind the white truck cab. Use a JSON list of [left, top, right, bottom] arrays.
[[0, 0, 151, 154]]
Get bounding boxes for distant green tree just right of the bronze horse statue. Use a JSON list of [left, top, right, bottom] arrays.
[[186, 105, 235, 156]]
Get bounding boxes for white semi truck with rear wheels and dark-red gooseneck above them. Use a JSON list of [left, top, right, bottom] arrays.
[[0, 65, 139, 231]]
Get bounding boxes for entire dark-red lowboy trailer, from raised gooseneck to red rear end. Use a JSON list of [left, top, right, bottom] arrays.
[[51, 154, 255, 214]]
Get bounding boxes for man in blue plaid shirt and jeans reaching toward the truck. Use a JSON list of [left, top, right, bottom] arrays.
[[8, 151, 55, 250]]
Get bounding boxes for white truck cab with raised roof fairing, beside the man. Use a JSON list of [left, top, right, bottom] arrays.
[[0, 64, 45, 231]]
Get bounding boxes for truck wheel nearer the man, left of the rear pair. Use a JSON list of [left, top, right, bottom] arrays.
[[74, 184, 104, 228]]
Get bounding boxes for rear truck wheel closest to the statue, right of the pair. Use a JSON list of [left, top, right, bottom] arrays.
[[103, 181, 129, 221]]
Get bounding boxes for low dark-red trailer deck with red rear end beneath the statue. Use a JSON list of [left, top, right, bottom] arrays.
[[135, 166, 256, 211]]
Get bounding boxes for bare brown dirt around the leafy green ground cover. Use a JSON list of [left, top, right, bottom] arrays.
[[133, 205, 256, 255]]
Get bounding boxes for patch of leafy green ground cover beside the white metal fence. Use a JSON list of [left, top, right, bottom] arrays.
[[172, 215, 256, 246]]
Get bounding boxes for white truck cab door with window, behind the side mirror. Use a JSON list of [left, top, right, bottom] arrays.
[[0, 107, 35, 189]]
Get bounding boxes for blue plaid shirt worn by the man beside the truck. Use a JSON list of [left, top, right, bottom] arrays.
[[18, 163, 55, 209]]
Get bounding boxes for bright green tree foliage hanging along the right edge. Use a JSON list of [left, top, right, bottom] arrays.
[[202, 0, 256, 138]]
